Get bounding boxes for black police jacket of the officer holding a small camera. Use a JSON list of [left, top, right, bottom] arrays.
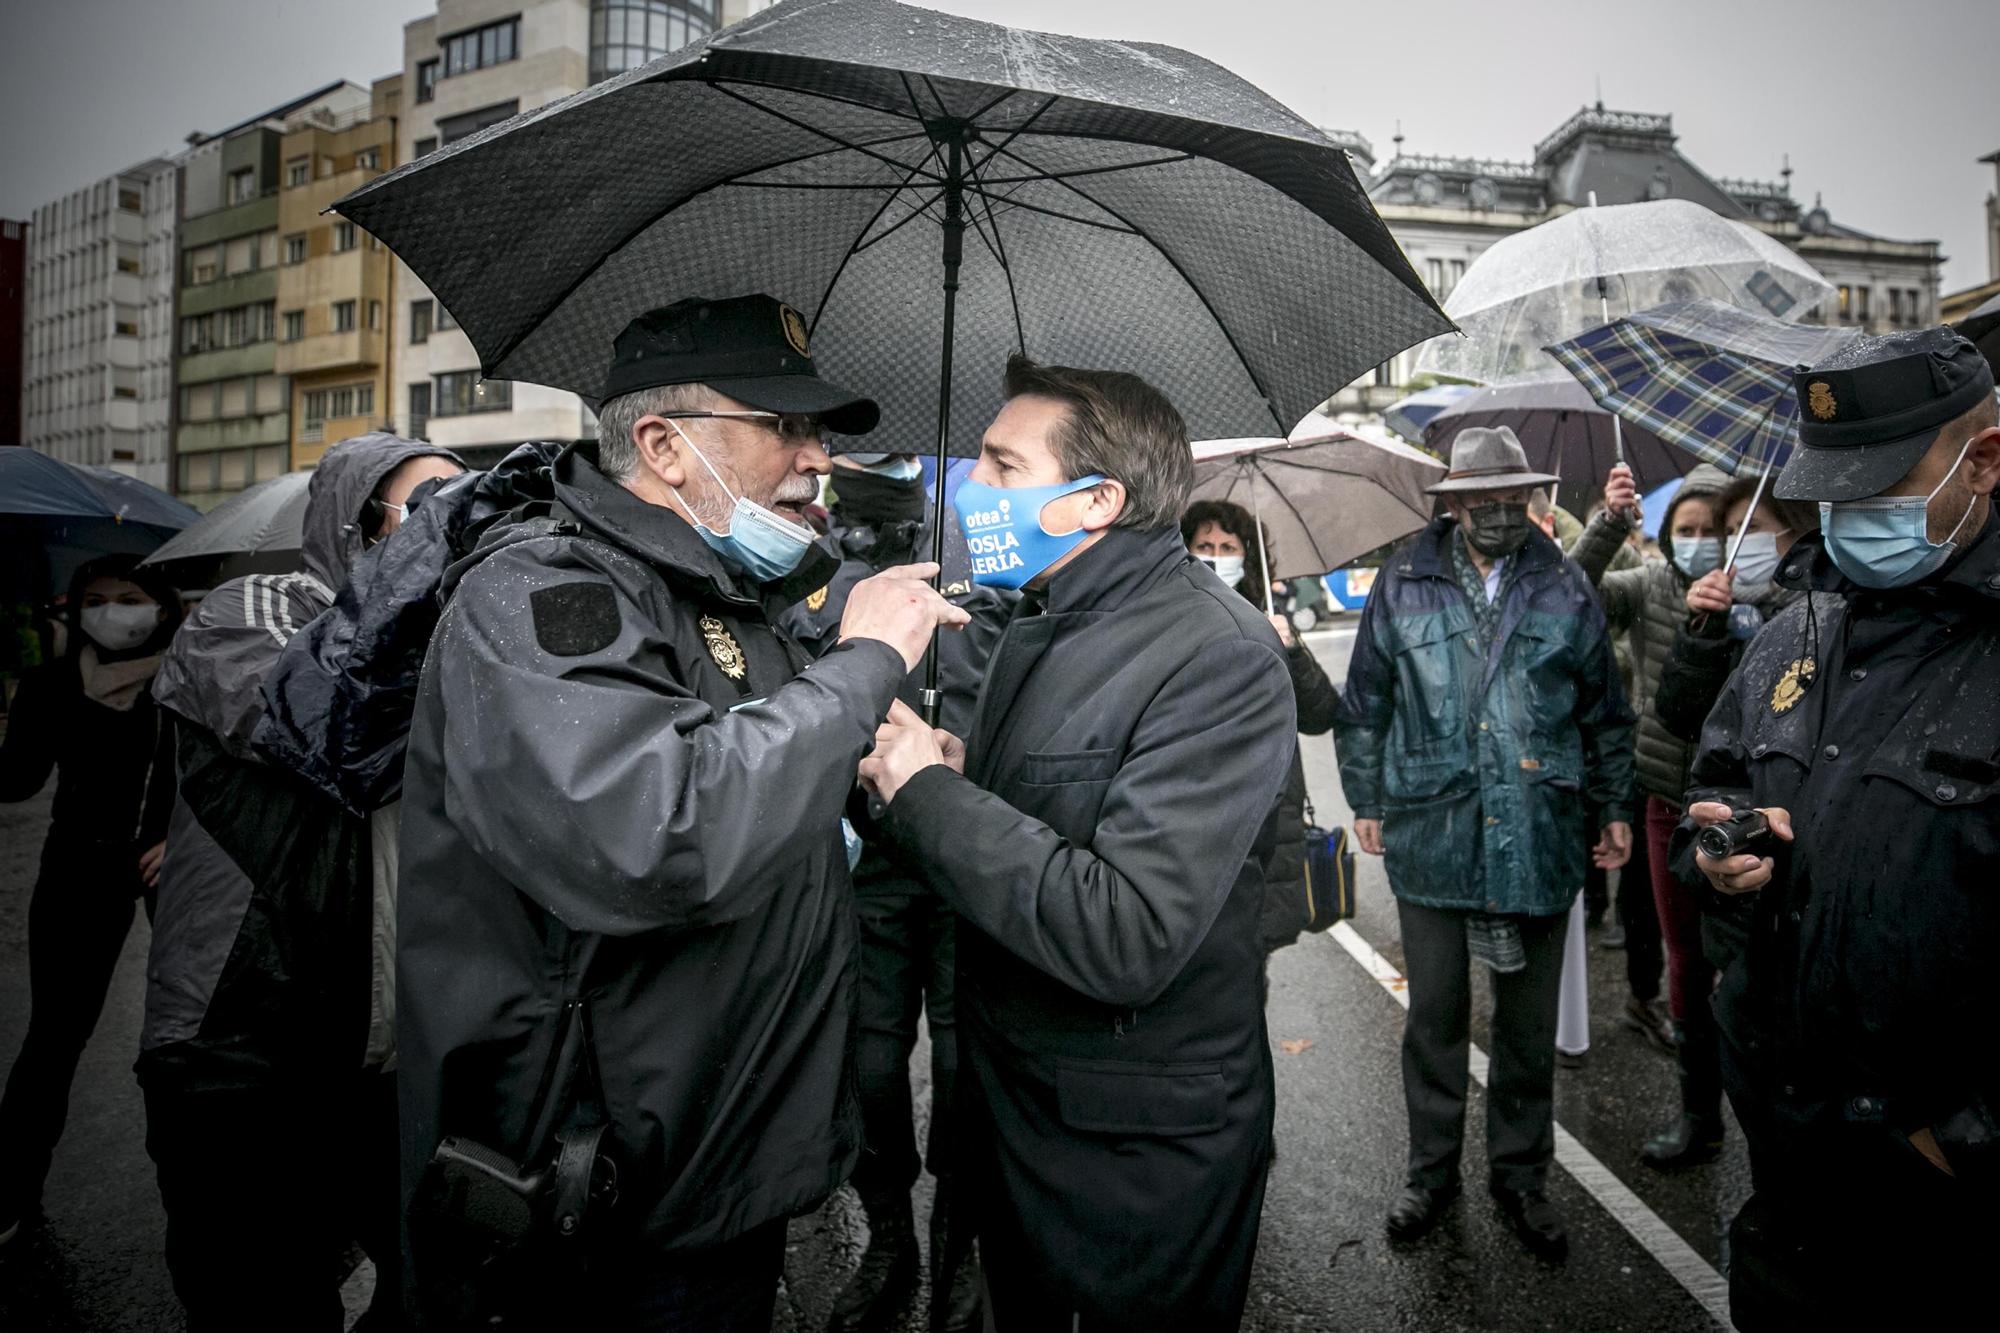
[[1688, 520, 2000, 1191]]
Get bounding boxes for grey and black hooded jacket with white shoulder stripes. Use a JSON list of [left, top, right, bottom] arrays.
[[140, 432, 452, 1087]]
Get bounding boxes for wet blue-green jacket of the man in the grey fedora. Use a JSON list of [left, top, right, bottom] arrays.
[[1334, 518, 1632, 917]]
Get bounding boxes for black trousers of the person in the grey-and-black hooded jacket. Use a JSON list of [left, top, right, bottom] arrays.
[[146, 1071, 402, 1333]]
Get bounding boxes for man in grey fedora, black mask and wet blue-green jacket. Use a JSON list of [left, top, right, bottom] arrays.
[[1336, 426, 1632, 1259]]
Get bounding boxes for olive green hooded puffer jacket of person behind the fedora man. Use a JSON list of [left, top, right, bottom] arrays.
[[1570, 464, 1730, 805]]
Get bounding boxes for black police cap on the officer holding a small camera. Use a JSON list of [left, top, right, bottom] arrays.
[[1772, 328, 1994, 500]]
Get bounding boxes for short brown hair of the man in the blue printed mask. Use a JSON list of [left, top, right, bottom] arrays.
[[1006, 352, 1194, 530]]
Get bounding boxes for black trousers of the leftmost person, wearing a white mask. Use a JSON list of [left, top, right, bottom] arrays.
[[0, 831, 144, 1213]]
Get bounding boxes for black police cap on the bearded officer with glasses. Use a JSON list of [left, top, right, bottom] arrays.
[[604, 294, 882, 434]]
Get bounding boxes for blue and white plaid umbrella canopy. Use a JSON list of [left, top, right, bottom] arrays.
[[1548, 300, 1860, 474]]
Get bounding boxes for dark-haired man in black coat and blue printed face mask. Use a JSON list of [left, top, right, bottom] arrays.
[[862, 358, 1296, 1331]]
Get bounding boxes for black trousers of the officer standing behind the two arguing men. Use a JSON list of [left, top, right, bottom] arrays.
[[854, 868, 958, 1201]]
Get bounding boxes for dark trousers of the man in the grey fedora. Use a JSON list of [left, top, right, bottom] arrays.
[[1396, 899, 1570, 1189]]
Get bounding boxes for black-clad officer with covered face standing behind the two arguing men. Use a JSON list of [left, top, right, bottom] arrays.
[[782, 456, 1020, 1333]]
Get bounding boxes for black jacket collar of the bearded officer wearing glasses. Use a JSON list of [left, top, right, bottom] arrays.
[[554, 440, 840, 606]]
